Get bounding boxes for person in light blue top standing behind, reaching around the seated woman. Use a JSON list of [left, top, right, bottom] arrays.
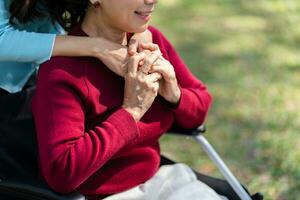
[[0, 0, 151, 183]]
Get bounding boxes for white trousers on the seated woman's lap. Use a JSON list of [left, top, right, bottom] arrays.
[[104, 163, 227, 200]]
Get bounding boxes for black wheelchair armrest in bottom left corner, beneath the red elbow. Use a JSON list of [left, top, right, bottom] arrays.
[[0, 180, 86, 200]]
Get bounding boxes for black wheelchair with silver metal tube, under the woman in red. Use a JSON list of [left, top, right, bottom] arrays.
[[0, 117, 263, 200]]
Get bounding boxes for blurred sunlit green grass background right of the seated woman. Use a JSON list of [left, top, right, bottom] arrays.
[[152, 0, 300, 200]]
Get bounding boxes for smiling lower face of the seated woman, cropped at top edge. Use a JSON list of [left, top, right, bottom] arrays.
[[101, 0, 158, 33]]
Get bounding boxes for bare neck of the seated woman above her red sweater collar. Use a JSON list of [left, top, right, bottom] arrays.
[[81, 7, 127, 45]]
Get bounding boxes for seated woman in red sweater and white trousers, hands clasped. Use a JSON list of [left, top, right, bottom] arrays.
[[32, 0, 219, 199]]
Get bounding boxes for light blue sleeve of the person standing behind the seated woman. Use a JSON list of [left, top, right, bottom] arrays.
[[0, 0, 56, 64]]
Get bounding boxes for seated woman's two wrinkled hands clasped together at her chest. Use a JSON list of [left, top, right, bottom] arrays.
[[123, 38, 180, 121]]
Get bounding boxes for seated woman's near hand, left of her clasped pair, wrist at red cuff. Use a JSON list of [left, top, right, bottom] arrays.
[[122, 52, 160, 121]]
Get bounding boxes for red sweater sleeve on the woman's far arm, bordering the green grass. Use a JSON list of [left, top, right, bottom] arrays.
[[150, 27, 212, 128]]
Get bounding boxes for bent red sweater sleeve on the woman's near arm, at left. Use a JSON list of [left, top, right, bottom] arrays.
[[32, 63, 139, 193]]
